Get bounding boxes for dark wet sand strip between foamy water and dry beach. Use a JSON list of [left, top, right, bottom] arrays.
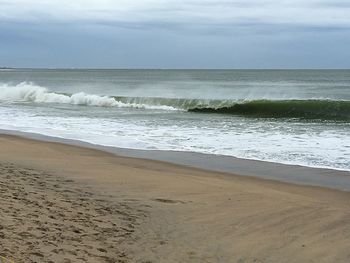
[[0, 129, 350, 192]]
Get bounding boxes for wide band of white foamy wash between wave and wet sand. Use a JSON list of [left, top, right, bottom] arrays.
[[0, 96, 350, 171]]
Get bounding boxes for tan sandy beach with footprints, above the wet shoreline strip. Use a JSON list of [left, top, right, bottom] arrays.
[[0, 136, 350, 263]]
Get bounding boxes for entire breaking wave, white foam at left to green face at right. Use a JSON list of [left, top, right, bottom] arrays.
[[0, 82, 350, 121]]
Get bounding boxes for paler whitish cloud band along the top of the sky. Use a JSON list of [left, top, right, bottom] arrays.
[[0, 0, 350, 27]]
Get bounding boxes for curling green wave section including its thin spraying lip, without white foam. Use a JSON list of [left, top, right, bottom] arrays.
[[115, 97, 350, 120]]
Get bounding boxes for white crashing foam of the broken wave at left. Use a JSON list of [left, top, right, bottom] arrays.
[[0, 82, 177, 110]]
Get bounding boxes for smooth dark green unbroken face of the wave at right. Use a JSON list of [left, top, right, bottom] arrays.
[[189, 100, 350, 120]]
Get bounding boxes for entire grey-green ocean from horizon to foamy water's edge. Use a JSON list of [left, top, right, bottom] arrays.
[[0, 69, 350, 171]]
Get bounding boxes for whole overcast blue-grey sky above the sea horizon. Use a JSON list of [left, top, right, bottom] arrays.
[[0, 0, 350, 69]]
